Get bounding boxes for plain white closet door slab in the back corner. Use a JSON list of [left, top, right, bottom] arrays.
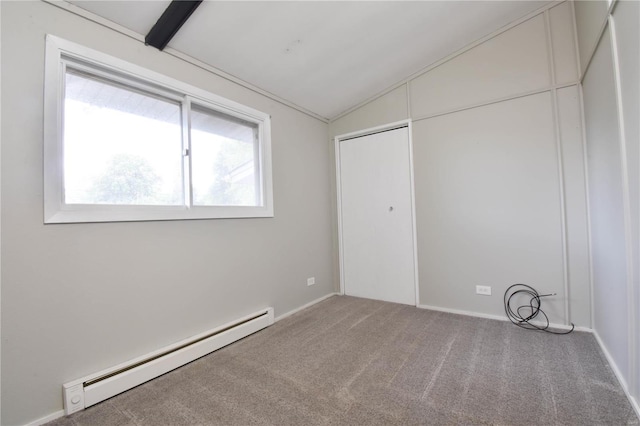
[[339, 127, 416, 305]]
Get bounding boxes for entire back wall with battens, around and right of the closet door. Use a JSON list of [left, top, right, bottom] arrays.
[[330, 3, 591, 327]]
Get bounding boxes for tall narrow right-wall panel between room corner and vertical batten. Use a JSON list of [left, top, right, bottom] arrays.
[[583, 30, 628, 374]]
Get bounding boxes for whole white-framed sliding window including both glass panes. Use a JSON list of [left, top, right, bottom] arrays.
[[44, 36, 273, 223]]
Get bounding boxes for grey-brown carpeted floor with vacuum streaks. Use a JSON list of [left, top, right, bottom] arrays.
[[49, 296, 639, 426]]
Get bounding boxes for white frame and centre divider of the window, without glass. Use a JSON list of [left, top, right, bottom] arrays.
[[44, 35, 273, 223]]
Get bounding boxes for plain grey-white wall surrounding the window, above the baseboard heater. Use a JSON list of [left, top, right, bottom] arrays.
[[0, 2, 334, 425]]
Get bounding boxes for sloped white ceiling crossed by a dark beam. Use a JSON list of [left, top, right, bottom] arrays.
[[70, 0, 548, 118]]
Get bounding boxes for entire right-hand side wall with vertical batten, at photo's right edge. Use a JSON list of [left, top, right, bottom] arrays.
[[576, 1, 640, 412]]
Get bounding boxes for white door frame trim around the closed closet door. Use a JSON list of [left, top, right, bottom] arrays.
[[333, 119, 420, 306]]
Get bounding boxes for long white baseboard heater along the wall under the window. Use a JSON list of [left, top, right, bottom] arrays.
[[62, 308, 274, 415]]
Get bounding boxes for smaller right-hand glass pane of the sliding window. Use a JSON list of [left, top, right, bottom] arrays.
[[191, 105, 262, 206]]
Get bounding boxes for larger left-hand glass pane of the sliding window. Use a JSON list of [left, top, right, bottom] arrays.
[[64, 69, 184, 205]]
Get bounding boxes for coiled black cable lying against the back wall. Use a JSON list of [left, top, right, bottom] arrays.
[[504, 284, 575, 334]]
